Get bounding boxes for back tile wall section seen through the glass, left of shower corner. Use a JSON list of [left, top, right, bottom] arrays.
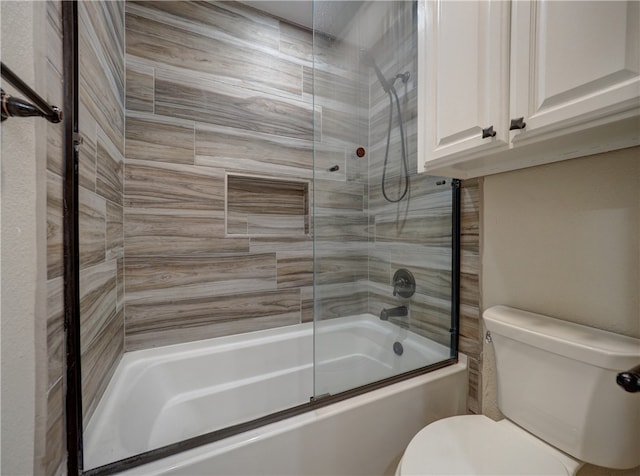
[[304, 26, 371, 320]]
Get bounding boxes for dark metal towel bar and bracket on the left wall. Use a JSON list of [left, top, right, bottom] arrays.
[[0, 62, 62, 124]]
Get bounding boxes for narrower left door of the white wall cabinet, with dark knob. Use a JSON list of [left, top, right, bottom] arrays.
[[421, 0, 510, 166]]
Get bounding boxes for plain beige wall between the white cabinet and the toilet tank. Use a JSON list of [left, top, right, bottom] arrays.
[[481, 147, 640, 476]]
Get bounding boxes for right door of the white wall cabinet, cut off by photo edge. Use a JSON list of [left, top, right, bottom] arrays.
[[511, 0, 640, 143]]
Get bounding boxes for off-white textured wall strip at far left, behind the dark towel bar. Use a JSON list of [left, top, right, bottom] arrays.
[[0, 2, 47, 475]]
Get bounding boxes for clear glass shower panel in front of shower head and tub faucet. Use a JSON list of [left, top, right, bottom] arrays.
[[313, 0, 456, 398]]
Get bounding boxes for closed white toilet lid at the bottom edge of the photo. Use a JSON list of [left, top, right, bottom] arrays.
[[396, 415, 582, 476]]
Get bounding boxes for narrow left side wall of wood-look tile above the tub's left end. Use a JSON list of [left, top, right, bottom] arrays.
[[78, 0, 125, 427]]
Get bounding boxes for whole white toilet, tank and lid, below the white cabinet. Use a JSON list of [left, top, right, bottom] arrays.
[[396, 306, 640, 476]]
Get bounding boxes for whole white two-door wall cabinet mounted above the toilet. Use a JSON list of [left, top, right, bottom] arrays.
[[419, 0, 640, 178]]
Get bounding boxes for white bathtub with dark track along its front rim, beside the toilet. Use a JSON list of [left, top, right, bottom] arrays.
[[84, 315, 467, 475]]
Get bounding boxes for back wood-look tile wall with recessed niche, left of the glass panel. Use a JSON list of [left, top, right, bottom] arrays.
[[124, 1, 322, 350]]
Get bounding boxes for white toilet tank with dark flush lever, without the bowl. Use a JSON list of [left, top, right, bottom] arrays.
[[483, 306, 640, 469]]
